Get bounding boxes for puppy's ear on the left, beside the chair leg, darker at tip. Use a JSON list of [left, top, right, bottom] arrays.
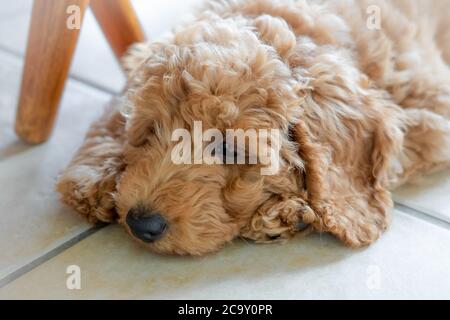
[[56, 101, 125, 223]]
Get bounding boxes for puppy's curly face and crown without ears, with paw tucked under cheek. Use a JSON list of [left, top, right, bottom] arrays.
[[115, 23, 316, 254]]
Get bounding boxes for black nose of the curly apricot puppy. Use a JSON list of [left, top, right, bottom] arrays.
[[126, 208, 167, 242]]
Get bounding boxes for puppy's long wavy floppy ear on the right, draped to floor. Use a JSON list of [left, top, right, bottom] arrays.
[[295, 84, 410, 247]]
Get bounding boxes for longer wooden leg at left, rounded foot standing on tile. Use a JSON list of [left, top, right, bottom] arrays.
[[15, 0, 89, 143]]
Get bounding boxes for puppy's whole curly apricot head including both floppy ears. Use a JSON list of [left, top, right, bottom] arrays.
[[59, 11, 396, 254]]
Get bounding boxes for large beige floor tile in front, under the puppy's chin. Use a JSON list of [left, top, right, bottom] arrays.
[[0, 212, 450, 299]]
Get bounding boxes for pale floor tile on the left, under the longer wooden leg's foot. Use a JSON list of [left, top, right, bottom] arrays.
[[0, 52, 109, 279]]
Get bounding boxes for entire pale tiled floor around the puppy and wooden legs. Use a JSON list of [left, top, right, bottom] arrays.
[[0, 0, 450, 299]]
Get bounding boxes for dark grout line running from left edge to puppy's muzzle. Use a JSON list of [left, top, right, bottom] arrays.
[[0, 224, 107, 288]]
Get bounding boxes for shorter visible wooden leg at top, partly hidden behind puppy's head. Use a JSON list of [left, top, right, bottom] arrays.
[[91, 0, 145, 59]]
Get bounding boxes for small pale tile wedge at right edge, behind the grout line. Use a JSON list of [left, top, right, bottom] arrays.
[[394, 170, 450, 223]]
